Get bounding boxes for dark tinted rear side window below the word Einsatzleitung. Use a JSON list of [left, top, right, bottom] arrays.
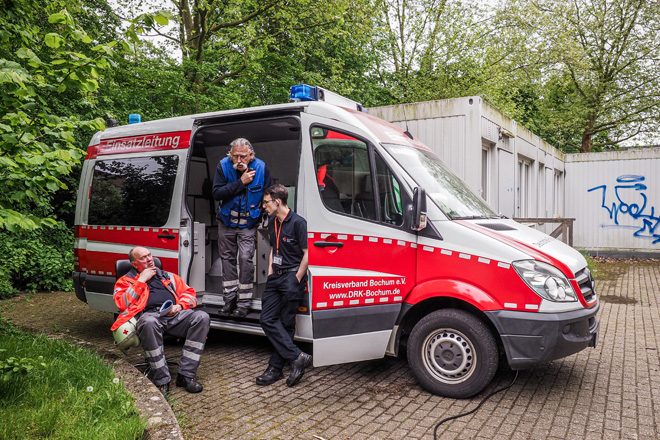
[[88, 156, 179, 227]]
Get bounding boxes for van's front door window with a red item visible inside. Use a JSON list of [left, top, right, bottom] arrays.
[[312, 127, 403, 226]]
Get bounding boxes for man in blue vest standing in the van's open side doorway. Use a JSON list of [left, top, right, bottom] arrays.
[[213, 138, 272, 318]]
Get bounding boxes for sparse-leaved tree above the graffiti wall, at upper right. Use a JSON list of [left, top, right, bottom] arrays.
[[505, 0, 660, 152]]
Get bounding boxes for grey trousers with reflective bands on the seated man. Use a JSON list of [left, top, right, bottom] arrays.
[[137, 309, 210, 385]]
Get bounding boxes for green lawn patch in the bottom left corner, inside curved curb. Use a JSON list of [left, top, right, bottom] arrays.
[[0, 318, 146, 440]]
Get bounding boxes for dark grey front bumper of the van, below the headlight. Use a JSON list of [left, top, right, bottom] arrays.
[[485, 303, 600, 370]]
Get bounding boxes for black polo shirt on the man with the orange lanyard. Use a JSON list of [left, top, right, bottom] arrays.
[[268, 210, 307, 270]]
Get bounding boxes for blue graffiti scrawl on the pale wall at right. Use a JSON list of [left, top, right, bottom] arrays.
[[587, 175, 660, 244]]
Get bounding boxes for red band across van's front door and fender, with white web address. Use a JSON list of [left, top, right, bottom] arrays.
[[308, 232, 541, 312]]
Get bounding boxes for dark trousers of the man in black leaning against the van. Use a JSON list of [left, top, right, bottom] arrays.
[[260, 269, 307, 370]]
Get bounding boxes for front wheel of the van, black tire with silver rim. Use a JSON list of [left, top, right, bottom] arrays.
[[408, 309, 499, 399]]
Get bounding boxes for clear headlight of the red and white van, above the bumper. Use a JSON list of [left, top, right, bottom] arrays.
[[512, 260, 577, 302]]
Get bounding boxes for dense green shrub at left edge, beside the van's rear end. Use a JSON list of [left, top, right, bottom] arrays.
[[0, 222, 73, 298]]
